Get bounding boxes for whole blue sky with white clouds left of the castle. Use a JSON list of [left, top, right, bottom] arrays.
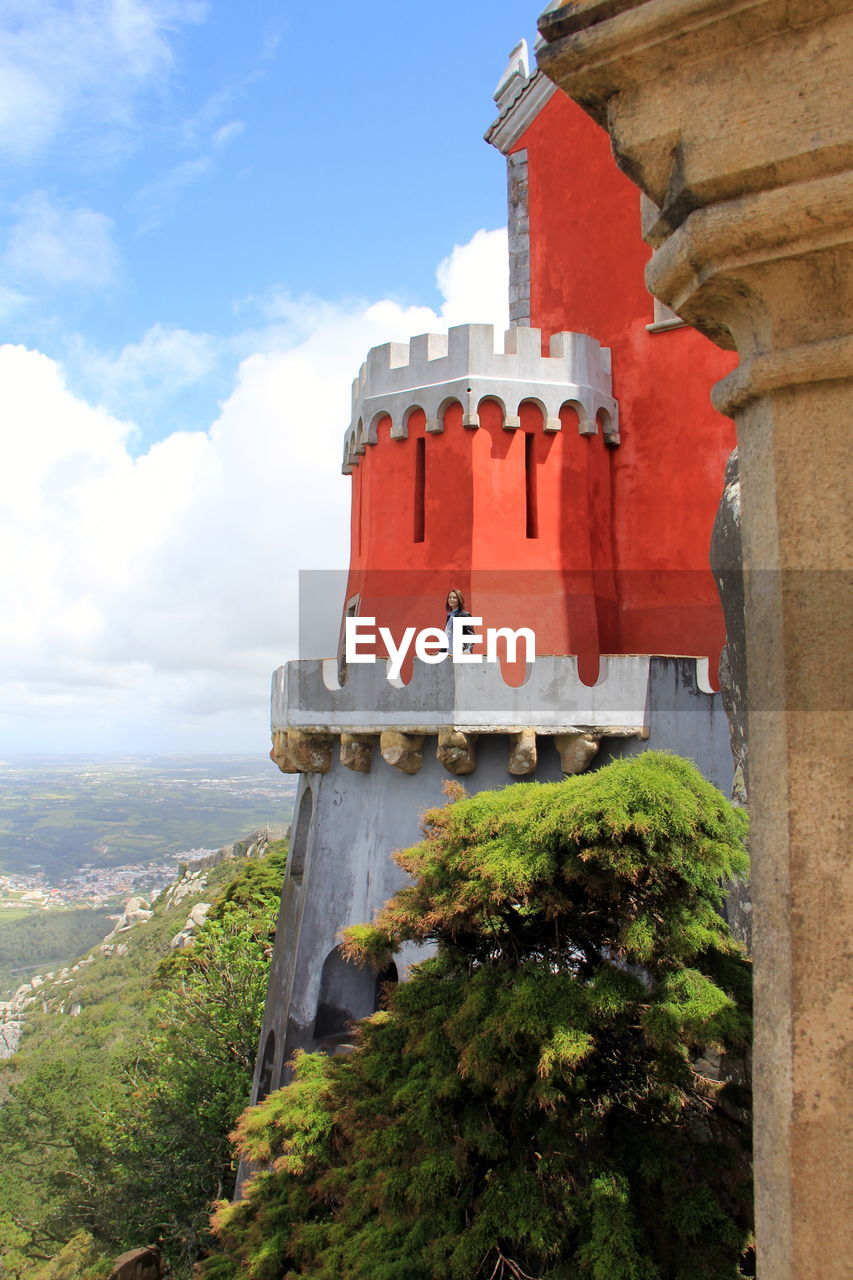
[[0, 0, 537, 753]]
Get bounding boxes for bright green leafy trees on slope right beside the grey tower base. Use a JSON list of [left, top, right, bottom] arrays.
[[101, 852, 284, 1270]]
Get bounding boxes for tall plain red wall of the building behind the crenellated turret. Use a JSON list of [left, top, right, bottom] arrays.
[[508, 90, 734, 671]]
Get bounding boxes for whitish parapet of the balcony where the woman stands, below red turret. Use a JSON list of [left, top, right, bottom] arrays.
[[272, 654, 651, 736]]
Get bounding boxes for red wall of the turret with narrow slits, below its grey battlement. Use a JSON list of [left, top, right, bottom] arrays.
[[347, 399, 619, 681]]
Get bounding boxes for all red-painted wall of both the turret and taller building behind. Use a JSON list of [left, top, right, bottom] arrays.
[[347, 93, 734, 680]]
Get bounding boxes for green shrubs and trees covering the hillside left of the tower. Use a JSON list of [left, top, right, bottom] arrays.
[[0, 842, 286, 1280]]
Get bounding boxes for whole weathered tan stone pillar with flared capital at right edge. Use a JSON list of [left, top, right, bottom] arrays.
[[539, 0, 853, 1280]]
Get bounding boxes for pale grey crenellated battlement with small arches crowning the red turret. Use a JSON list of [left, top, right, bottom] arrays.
[[343, 324, 619, 474]]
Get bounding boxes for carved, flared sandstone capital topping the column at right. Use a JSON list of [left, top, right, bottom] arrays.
[[539, 0, 853, 355]]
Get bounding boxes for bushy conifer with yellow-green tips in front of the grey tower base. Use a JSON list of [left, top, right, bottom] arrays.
[[204, 753, 751, 1280]]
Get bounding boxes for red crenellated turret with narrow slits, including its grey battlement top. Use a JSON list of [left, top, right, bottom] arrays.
[[343, 325, 619, 680]]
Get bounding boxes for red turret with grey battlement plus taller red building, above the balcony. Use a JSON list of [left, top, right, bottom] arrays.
[[343, 42, 734, 682]]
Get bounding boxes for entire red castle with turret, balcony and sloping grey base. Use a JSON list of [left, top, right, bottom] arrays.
[[252, 45, 734, 1100]]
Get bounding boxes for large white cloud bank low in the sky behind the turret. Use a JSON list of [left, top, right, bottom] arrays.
[[0, 233, 506, 750]]
